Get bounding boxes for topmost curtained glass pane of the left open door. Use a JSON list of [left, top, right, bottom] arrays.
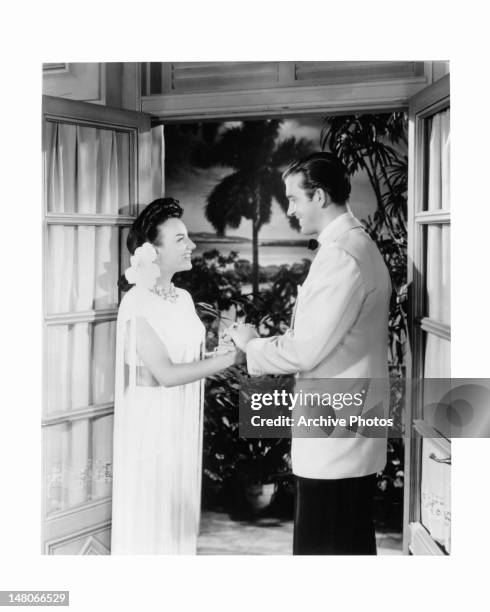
[[46, 121, 131, 215]]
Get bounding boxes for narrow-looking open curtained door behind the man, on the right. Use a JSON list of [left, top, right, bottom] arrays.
[[404, 75, 451, 555]]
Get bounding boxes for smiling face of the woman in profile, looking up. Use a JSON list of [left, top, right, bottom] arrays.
[[156, 218, 196, 274]]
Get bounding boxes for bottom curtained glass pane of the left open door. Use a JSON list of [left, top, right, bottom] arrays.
[[43, 415, 113, 515]]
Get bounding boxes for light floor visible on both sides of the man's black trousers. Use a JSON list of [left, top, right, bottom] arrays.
[[197, 512, 402, 555]]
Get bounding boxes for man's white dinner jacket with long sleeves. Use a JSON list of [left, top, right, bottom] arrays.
[[246, 212, 391, 479]]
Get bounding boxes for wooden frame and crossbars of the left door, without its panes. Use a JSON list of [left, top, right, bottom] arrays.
[[41, 96, 151, 554]]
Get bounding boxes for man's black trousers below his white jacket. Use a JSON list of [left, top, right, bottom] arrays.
[[293, 474, 376, 555]]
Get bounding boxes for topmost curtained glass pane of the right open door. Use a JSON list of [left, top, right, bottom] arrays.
[[424, 109, 450, 210]]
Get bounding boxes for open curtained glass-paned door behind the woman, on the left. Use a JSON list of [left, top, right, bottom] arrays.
[[42, 96, 151, 554]]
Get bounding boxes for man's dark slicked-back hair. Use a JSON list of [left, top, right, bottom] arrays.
[[282, 153, 350, 204]]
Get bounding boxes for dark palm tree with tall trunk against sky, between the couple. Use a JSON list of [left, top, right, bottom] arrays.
[[194, 120, 312, 299]]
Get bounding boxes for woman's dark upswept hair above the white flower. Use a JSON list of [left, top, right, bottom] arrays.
[[118, 198, 184, 291]]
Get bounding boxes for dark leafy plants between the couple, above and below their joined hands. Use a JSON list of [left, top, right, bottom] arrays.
[[176, 251, 310, 505]]
